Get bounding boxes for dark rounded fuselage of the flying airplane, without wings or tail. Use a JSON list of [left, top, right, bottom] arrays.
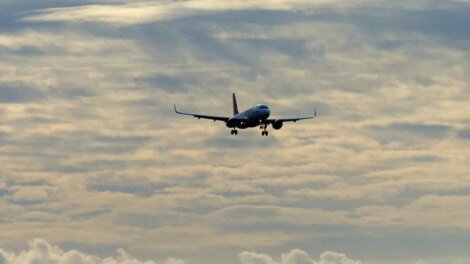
[[226, 104, 271, 129]]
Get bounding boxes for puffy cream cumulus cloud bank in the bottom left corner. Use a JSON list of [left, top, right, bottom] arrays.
[[0, 239, 185, 264]]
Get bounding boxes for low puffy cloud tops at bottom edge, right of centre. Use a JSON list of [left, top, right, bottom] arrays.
[[238, 249, 362, 264]]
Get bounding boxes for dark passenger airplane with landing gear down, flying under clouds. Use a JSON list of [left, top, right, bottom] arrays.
[[174, 93, 317, 136]]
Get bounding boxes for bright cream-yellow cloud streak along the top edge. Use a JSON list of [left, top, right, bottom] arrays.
[[22, 0, 362, 25]]
